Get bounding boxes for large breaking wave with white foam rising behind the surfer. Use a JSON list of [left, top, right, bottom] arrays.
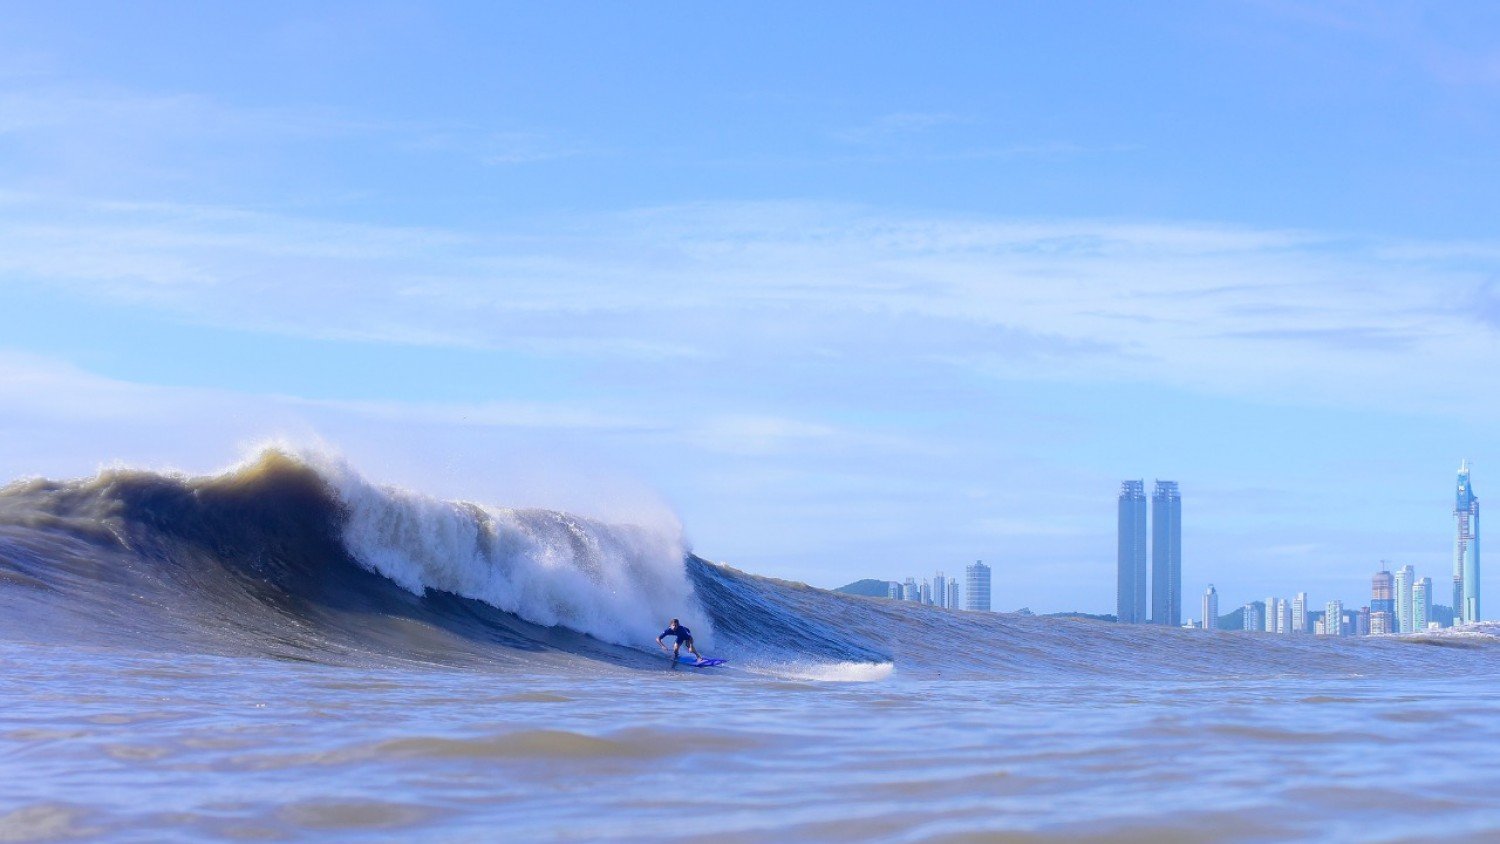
[[0, 450, 1500, 681]]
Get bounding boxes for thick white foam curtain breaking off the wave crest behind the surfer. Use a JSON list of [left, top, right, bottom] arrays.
[[300, 454, 713, 648]]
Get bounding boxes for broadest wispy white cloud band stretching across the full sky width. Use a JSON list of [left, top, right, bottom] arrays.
[[0, 193, 1500, 414]]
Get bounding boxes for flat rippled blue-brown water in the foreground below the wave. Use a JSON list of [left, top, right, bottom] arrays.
[[0, 643, 1500, 843]]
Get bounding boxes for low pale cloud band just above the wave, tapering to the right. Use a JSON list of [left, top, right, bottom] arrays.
[[0, 348, 888, 479]]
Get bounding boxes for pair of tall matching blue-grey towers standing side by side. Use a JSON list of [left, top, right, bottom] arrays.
[[1115, 480, 1182, 627]]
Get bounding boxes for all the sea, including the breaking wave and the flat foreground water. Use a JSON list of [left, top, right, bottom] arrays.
[[0, 453, 1500, 843]]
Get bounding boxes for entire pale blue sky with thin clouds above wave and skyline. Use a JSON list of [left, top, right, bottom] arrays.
[[0, 1, 1500, 615]]
